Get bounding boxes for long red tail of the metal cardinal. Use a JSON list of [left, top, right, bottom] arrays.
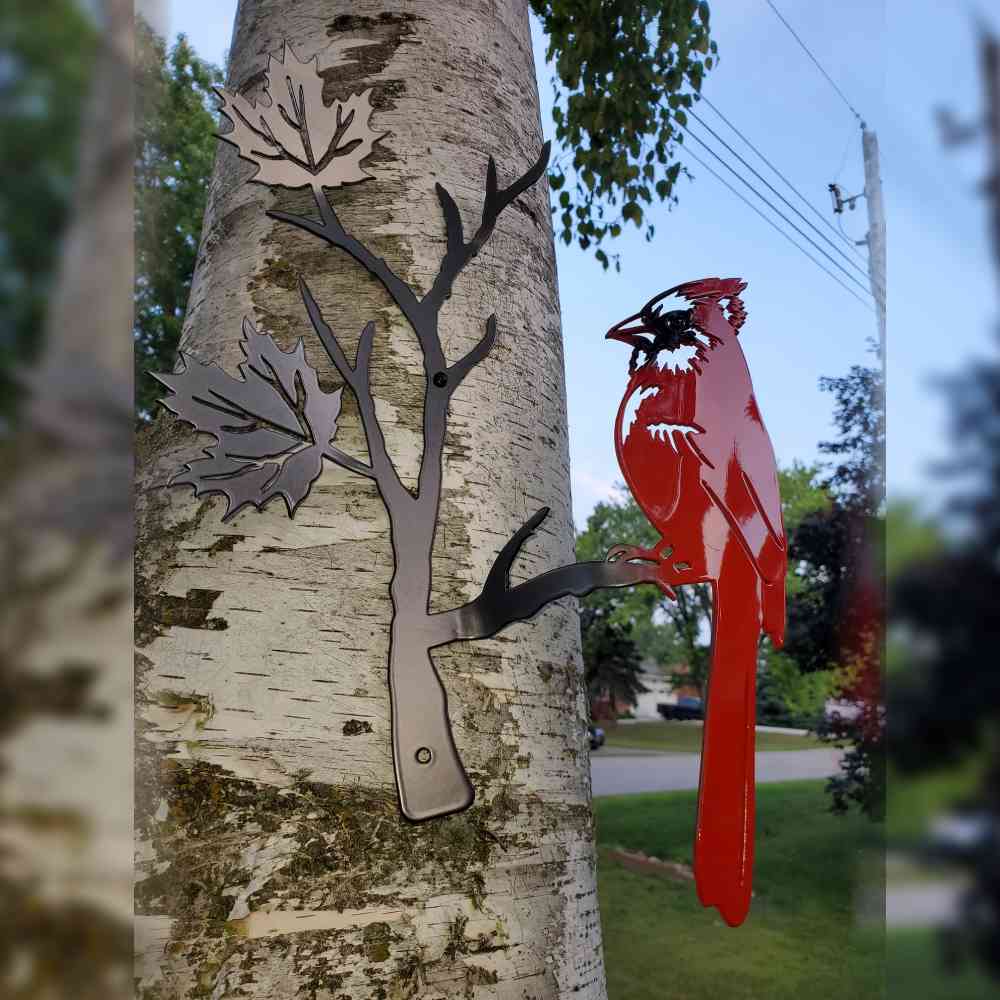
[[694, 546, 763, 927]]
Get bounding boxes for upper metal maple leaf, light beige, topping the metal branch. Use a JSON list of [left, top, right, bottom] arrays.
[[215, 43, 387, 188]]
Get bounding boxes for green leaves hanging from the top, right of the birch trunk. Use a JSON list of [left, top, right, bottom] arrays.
[[531, 0, 718, 268]]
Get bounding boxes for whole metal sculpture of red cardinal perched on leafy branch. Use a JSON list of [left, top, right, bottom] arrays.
[[155, 37, 785, 923]]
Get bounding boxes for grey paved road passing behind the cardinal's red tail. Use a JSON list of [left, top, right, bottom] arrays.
[[590, 748, 843, 795]]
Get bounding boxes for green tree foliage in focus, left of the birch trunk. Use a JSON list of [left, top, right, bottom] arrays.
[[134, 19, 222, 419]]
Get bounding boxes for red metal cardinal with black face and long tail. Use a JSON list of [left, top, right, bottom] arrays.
[[607, 278, 787, 926]]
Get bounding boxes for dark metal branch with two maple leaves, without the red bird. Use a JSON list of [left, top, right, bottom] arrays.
[[156, 46, 657, 820]]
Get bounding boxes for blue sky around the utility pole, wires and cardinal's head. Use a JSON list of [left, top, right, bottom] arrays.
[[166, 0, 996, 525]]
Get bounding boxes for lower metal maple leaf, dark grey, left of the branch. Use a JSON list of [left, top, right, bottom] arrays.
[[153, 319, 343, 521]]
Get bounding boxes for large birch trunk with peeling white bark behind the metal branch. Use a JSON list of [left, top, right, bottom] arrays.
[[136, 0, 605, 1000]]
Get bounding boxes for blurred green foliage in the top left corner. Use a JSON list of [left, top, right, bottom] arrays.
[[0, 0, 97, 417]]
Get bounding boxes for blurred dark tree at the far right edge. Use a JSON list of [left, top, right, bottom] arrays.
[[890, 344, 1000, 772]]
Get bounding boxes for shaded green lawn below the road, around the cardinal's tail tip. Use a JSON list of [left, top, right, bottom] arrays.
[[594, 781, 884, 1000]]
